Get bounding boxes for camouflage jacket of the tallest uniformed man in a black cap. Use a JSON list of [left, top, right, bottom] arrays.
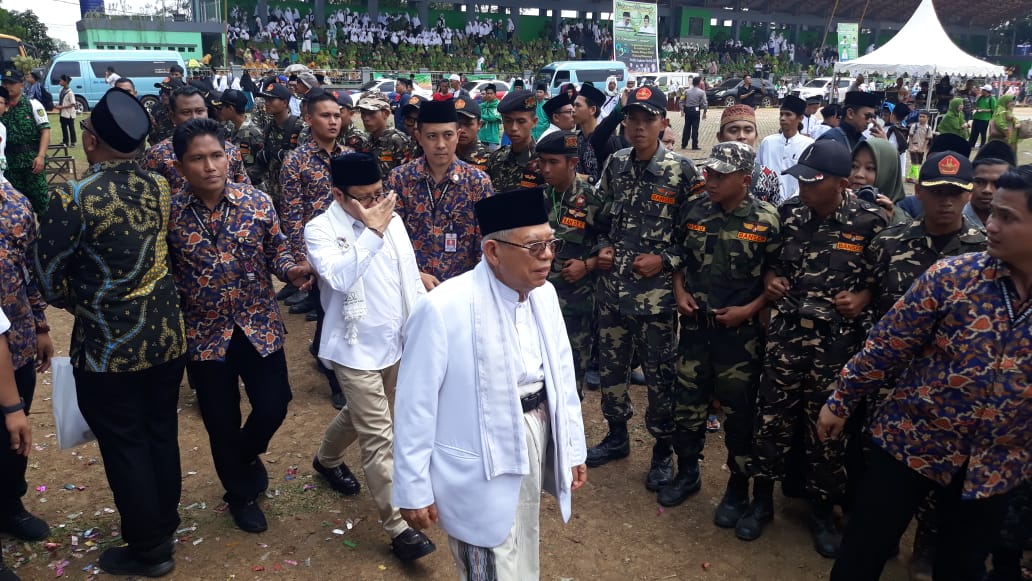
[[596, 146, 705, 315]]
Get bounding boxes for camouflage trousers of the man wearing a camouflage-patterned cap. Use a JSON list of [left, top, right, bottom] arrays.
[[674, 319, 763, 475]]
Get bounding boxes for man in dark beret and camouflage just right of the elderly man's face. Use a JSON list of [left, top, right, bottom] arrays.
[[537, 131, 602, 395]]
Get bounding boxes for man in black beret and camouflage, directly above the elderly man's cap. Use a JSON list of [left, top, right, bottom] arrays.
[[487, 91, 545, 192]]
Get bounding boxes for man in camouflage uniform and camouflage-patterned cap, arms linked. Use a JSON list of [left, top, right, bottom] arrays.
[[672, 141, 780, 518]]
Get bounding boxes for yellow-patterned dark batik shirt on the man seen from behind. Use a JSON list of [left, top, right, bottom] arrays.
[[35, 160, 186, 373]]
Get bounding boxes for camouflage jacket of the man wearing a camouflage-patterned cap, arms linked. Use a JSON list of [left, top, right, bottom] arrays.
[[678, 195, 781, 315]]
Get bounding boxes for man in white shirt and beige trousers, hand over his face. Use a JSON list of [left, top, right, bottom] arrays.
[[304, 153, 437, 561]]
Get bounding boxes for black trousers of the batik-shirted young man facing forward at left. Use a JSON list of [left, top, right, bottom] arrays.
[[187, 327, 292, 503]]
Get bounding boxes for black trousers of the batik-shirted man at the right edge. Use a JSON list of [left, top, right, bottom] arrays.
[[831, 447, 1009, 581]]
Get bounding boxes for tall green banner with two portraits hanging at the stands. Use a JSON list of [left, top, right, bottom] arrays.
[[613, 0, 659, 74]]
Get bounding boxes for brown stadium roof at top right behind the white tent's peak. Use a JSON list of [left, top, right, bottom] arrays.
[[685, 0, 1029, 28]]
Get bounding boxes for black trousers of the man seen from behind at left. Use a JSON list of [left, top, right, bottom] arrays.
[[72, 357, 186, 558]]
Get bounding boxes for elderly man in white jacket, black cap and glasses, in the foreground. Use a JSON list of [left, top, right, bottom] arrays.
[[394, 189, 587, 581]]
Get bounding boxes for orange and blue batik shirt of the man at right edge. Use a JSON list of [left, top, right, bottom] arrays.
[[828, 253, 1032, 499]]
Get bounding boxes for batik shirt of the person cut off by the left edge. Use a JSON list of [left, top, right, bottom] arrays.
[[0, 183, 46, 369]]
